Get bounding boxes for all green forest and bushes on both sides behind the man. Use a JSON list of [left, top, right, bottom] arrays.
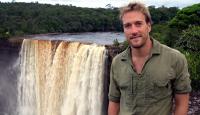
[[0, 2, 200, 90]]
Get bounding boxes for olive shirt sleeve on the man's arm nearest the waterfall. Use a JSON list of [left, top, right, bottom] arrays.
[[108, 63, 121, 102]]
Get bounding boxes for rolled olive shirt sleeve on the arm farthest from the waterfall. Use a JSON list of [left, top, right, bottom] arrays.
[[174, 54, 192, 94]]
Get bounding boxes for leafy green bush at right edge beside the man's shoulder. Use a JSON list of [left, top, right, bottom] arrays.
[[176, 26, 200, 90]]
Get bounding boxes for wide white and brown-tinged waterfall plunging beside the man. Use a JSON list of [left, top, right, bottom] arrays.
[[17, 39, 106, 115]]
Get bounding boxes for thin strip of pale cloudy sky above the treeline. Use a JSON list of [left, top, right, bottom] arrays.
[[0, 0, 200, 8]]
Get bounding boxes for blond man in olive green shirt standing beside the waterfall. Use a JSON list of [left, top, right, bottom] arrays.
[[108, 3, 191, 115]]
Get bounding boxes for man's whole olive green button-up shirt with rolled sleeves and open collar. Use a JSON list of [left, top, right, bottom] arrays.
[[109, 39, 191, 115]]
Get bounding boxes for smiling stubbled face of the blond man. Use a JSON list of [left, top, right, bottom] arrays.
[[122, 11, 151, 48]]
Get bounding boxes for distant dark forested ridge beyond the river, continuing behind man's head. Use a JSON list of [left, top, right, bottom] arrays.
[[0, 3, 178, 38]]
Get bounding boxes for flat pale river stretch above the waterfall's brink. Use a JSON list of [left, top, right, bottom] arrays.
[[29, 32, 125, 45]]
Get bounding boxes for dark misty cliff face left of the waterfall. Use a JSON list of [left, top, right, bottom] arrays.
[[0, 39, 22, 115]]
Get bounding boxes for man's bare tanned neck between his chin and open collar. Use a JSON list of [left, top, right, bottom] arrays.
[[131, 38, 153, 58]]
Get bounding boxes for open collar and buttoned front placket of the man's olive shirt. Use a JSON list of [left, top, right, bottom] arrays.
[[122, 38, 159, 115]]
